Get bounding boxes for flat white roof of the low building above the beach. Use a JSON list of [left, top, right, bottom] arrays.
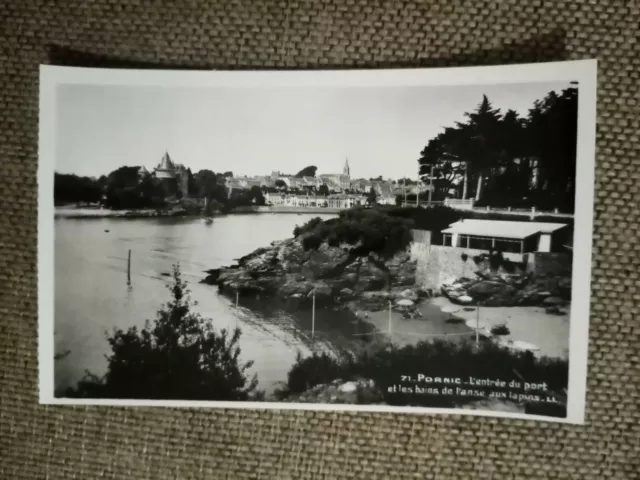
[[442, 219, 567, 240]]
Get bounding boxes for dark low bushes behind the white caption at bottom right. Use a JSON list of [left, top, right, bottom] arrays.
[[279, 340, 569, 415]]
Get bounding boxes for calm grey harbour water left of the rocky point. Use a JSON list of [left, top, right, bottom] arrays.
[[55, 214, 370, 392]]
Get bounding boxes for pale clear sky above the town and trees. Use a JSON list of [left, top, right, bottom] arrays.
[[56, 82, 569, 179]]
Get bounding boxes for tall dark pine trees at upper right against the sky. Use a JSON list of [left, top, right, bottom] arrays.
[[418, 88, 578, 211]]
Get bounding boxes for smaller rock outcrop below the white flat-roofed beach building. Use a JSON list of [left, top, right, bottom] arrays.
[[442, 272, 571, 308]]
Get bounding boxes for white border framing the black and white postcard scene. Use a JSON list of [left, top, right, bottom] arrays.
[[38, 60, 597, 424]]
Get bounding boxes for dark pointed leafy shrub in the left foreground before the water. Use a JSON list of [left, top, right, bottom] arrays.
[[65, 266, 260, 400]]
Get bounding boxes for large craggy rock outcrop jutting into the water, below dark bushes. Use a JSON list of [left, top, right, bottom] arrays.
[[203, 238, 424, 308]]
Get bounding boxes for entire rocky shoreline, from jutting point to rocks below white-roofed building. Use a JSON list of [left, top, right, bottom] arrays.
[[202, 233, 571, 318]]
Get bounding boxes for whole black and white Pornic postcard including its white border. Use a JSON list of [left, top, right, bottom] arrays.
[[38, 61, 596, 423]]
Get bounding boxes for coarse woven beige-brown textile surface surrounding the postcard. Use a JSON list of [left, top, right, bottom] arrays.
[[0, 0, 640, 479]]
